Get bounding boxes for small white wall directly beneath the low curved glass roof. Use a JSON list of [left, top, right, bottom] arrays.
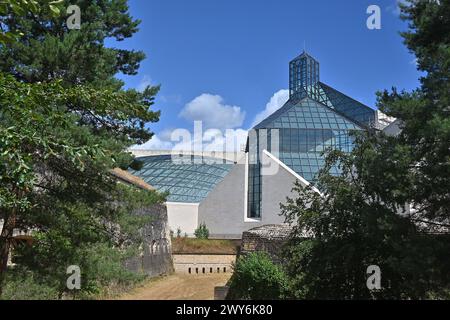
[[167, 202, 199, 237]]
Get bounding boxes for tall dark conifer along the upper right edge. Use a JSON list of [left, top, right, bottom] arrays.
[[373, 0, 450, 224]]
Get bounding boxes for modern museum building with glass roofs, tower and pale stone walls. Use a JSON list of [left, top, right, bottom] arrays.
[[130, 52, 398, 239]]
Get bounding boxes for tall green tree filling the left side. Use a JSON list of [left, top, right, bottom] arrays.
[[0, 0, 162, 296]]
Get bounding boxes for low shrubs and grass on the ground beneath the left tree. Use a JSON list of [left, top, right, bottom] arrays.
[[9, 234, 145, 300]]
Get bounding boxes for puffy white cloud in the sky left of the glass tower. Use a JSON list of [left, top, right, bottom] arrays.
[[180, 93, 245, 130]]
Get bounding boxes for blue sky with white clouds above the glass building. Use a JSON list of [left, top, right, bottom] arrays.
[[109, 0, 420, 148]]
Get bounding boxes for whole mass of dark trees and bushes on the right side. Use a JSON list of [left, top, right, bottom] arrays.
[[282, 1, 450, 299]]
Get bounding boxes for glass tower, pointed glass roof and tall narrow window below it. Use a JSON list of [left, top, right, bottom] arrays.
[[248, 53, 375, 218]]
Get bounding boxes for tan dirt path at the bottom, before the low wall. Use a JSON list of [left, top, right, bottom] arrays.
[[119, 273, 231, 300]]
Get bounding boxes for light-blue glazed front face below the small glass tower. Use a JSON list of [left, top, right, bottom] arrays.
[[251, 97, 363, 186]]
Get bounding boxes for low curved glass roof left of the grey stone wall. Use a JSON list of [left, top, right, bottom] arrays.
[[130, 155, 234, 203]]
